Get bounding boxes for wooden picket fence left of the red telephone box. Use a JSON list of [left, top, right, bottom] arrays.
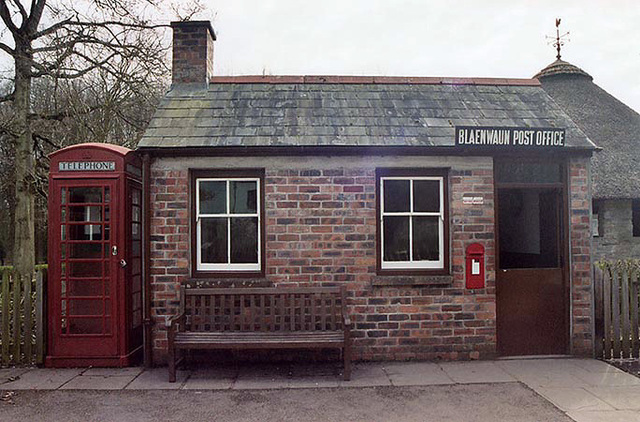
[[0, 265, 47, 366]]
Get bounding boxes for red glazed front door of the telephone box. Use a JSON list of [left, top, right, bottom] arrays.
[[49, 179, 122, 358]]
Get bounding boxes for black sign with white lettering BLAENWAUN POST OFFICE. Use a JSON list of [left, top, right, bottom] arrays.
[[456, 126, 566, 149]]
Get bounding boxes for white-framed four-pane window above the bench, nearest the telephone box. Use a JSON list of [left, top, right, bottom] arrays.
[[195, 177, 262, 272]]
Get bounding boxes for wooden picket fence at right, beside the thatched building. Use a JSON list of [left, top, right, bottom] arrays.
[[594, 259, 640, 359]]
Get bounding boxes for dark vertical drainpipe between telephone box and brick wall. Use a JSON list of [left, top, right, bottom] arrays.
[[142, 153, 153, 368]]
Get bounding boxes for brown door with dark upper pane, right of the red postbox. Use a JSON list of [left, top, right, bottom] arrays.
[[496, 187, 568, 356]]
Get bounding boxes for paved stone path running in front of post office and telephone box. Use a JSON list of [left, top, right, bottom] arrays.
[[0, 359, 640, 422]]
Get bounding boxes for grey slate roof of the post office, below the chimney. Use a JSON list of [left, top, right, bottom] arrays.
[[138, 76, 594, 149]]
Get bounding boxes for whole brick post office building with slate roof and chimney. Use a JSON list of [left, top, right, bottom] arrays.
[[138, 22, 595, 362]]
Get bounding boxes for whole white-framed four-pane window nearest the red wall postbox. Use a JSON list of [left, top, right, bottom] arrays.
[[379, 176, 446, 270]]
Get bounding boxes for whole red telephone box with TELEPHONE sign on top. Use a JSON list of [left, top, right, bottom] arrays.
[[45, 144, 143, 367]]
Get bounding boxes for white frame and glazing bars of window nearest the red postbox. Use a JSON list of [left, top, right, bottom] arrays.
[[379, 176, 445, 270]]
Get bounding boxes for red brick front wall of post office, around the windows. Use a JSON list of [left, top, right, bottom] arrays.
[[151, 157, 496, 360]]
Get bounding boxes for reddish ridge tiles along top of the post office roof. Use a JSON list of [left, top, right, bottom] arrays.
[[209, 75, 540, 86]]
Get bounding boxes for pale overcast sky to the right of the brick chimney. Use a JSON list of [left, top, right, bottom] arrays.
[[203, 0, 640, 111]]
